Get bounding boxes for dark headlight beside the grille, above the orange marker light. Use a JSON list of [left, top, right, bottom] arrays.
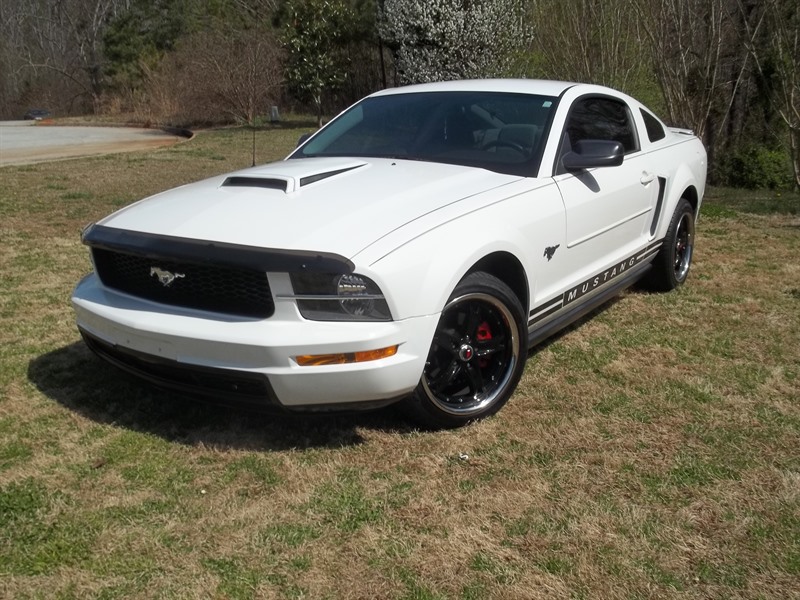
[[290, 273, 392, 321]]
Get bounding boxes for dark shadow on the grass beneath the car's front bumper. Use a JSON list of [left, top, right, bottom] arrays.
[[28, 342, 413, 451]]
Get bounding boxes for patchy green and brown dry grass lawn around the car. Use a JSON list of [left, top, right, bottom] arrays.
[[0, 126, 800, 600]]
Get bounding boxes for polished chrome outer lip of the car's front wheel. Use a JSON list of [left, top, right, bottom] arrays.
[[421, 293, 521, 417]]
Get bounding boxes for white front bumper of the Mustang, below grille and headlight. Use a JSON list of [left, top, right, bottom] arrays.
[[72, 274, 439, 409]]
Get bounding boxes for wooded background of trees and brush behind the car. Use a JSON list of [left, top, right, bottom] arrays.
[[0, 0, 800, 189]]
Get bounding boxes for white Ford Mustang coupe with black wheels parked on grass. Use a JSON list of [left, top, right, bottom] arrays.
[[72, 80, 706, 427]]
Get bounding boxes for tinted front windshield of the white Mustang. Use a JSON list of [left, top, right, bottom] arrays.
[[290, 92, 557, 176]]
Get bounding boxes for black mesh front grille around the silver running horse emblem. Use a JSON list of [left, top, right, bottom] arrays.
[[92, 248, 275, 319]]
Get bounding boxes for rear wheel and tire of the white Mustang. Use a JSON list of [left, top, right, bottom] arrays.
[[644, 198, 695, 292]]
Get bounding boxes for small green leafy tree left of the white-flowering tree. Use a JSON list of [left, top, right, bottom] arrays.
[[283, 0, 355, 127]]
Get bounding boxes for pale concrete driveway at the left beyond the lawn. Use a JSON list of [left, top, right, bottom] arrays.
[[0, 121, 182, 167]]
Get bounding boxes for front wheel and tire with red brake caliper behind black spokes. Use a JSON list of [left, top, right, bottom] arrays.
[[406, 272, 528, 429]]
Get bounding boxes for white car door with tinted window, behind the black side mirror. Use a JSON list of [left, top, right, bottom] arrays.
[[554, 95, 658, 287]]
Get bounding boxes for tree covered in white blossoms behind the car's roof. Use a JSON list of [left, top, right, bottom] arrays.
[[379, 0, 531, 83]]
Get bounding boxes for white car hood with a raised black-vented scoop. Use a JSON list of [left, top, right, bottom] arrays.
[[99, 158, 520, 258]]
